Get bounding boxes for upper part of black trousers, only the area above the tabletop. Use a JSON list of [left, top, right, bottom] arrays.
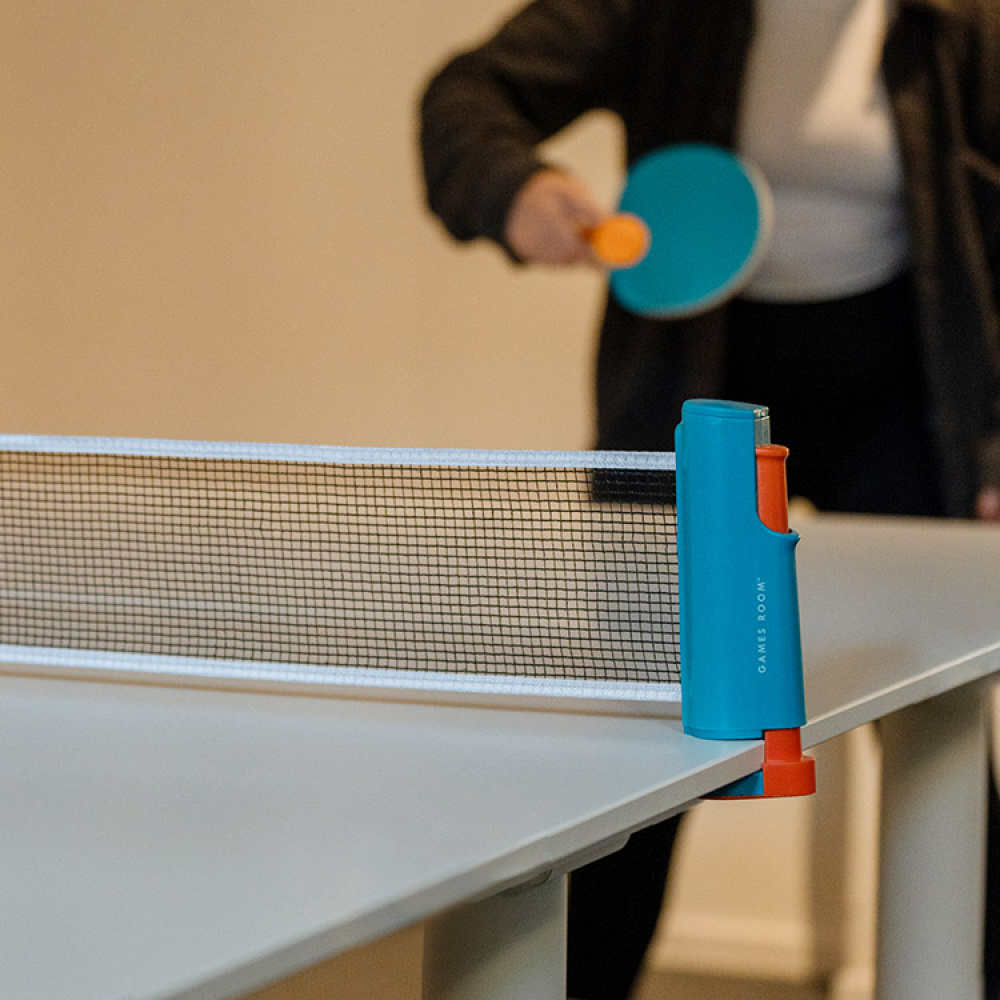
[[725, 277, 943, 517]]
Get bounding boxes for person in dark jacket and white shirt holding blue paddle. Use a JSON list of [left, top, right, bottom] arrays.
[[420, 0, 1000, 1000]]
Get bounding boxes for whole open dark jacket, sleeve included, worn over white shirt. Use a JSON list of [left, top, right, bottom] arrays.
[[421, 0, 1000, 516]]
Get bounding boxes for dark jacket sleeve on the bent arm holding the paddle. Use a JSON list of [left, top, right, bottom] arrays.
[[420, 0, 631, 245]]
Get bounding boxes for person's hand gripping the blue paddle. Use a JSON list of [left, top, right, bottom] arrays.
[[504, 169, 604, 265]]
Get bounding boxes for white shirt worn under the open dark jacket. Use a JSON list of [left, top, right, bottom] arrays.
[[738, 0, 909, 301]]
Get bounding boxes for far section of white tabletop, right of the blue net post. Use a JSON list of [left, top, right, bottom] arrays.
[[798, 516, 1000, 745]]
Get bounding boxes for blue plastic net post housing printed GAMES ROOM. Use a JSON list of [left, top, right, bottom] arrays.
[[676, 399, 806, 739]]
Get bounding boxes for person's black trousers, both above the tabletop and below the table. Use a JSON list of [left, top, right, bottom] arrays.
[[568, 277, 1000, 1000]]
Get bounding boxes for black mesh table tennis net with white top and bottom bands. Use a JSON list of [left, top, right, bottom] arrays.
[[0, 437, 680, 702]]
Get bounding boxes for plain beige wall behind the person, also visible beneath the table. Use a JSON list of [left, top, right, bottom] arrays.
[[0, 0, 876, 998]]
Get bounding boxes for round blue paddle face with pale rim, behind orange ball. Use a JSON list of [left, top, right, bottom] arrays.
[[611, 144, 771, 318]]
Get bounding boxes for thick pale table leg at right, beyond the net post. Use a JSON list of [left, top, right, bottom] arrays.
[[876, 684, 988, 1000]]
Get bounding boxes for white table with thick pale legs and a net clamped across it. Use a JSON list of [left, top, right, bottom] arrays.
[[0, 516, 1000, 1000]]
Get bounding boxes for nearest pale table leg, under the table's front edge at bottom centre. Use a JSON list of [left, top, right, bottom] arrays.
[[423, 875, 567, 1000]]
